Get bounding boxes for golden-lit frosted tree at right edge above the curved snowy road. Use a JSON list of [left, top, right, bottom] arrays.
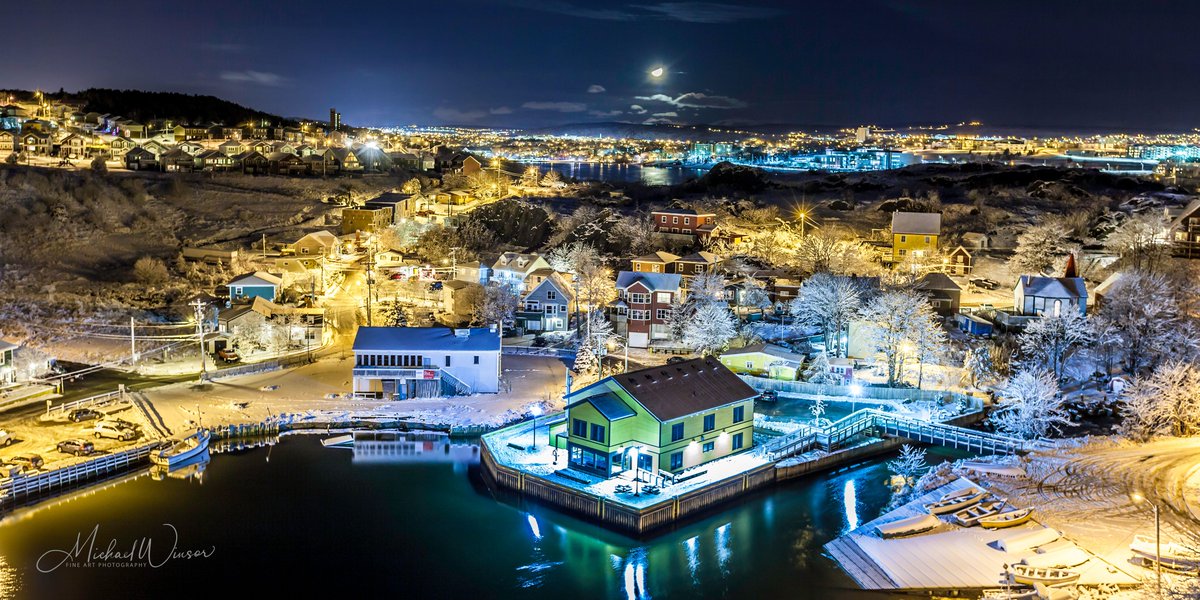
[[1122, 361, 1200, 439]]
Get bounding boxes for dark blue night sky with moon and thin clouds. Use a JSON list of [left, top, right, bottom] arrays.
[[9, 0, 1200, 131]]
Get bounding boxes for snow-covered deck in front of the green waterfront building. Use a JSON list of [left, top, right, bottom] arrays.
[[484, 421, 770, 509]]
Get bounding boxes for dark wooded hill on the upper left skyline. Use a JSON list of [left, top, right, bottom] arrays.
[[49, 88, 293, 125]]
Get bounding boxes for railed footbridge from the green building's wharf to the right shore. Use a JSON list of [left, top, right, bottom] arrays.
[[760, 408, 1033, 461]]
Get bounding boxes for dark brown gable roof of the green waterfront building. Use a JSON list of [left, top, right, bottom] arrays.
[[580, 356, 758, 421]]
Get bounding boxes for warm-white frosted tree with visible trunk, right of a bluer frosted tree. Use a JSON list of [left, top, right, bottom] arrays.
[[860, 290, 940, 385]]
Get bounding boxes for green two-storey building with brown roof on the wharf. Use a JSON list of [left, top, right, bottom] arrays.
[[553, 358, 757, 478]]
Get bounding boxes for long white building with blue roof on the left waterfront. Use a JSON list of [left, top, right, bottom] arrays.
[[354, 325, 500, 400]]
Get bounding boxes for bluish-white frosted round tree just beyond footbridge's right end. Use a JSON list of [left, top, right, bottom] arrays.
[[990, 371, 1074, 439]]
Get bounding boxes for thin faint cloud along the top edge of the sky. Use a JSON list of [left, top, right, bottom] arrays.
[[510, 0, 781, 24]]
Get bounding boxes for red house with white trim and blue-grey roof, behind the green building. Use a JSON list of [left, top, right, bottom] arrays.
[[612, 271, 683, 348]]
